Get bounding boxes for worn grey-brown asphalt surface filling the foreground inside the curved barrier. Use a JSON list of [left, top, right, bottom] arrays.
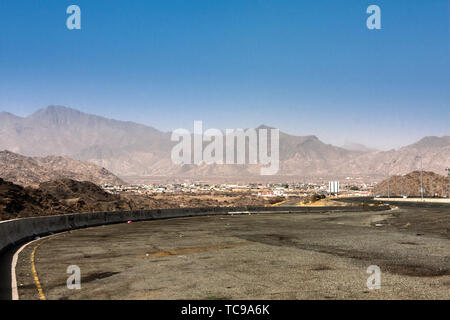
[[12, 207, 450, 299]]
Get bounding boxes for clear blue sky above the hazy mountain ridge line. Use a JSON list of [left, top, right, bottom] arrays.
[[0, 0, 450, 149]]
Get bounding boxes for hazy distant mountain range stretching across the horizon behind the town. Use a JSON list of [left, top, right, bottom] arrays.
[[0, 106, 450, 179]]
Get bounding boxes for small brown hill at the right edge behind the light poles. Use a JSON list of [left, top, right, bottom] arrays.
[[374, 171, 449, 197]]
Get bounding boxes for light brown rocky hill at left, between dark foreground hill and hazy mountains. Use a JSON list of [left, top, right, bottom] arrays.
[[0, 151, 125, 186]]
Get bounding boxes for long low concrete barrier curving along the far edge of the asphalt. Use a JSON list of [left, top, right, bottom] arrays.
[[0, 206, 389, 253]]
